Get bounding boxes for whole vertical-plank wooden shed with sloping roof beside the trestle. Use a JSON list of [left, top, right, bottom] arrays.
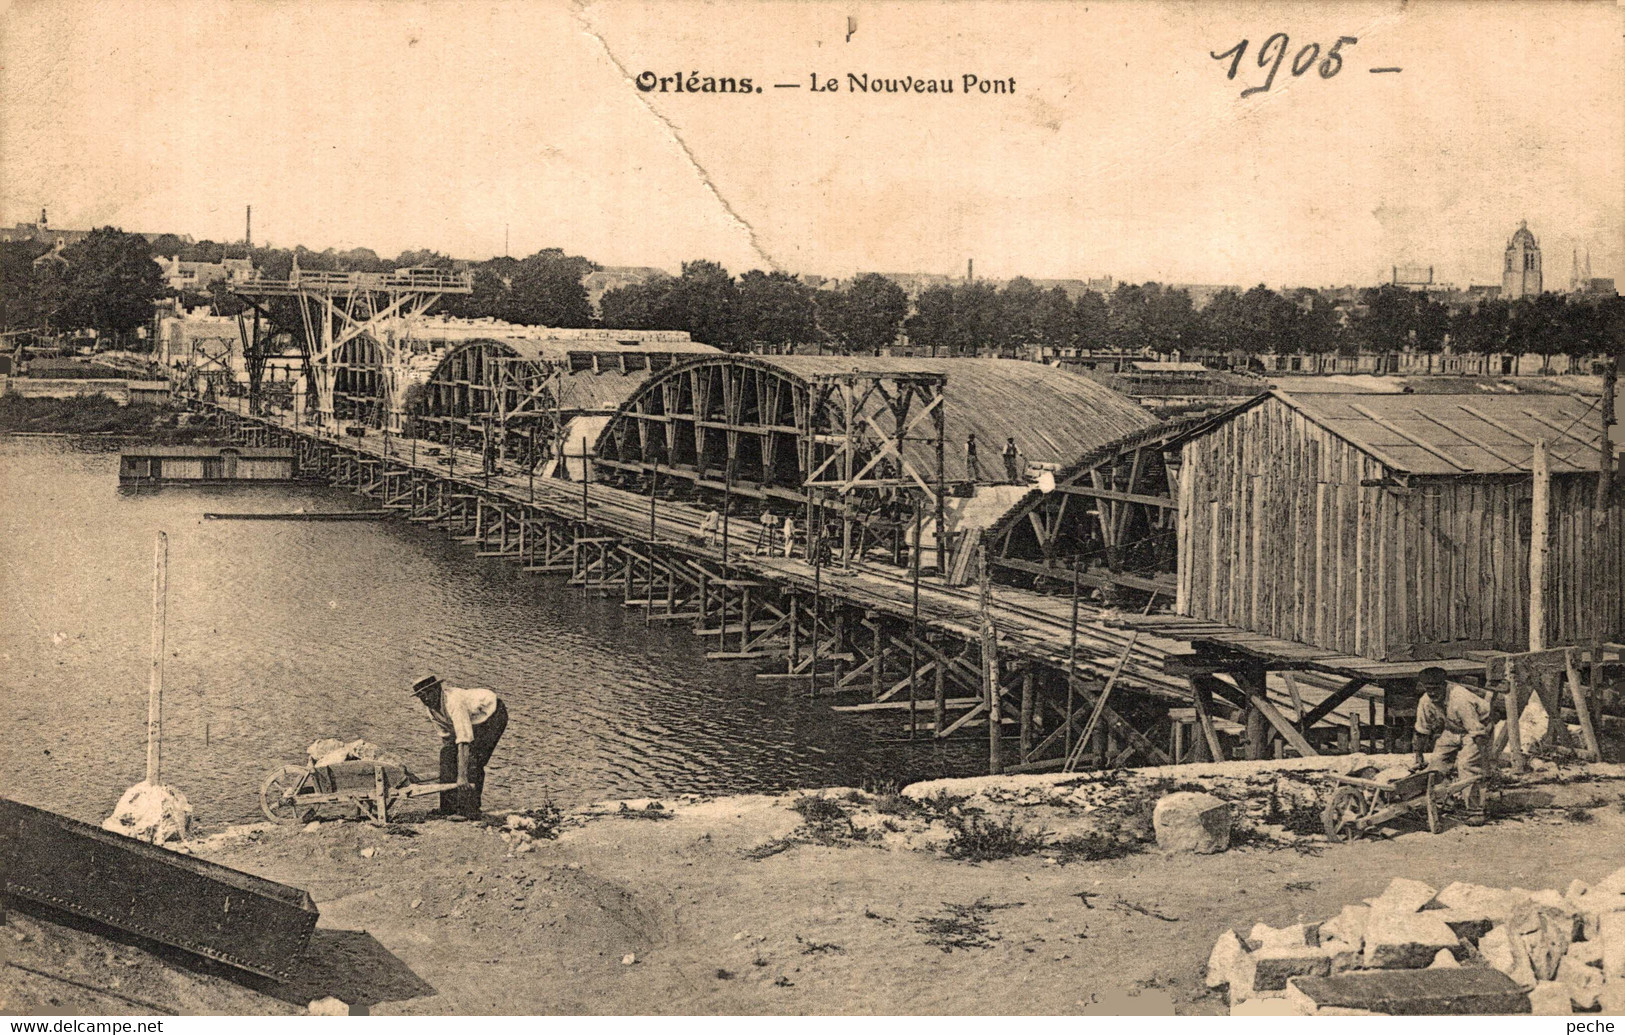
[[1178, 390, 1625, 661]]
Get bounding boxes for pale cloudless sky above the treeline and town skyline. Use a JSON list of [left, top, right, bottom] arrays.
[[0, 0, 1625, 288]]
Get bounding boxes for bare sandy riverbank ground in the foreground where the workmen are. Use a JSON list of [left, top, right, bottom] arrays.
[[9, 753, 1625, 1014]]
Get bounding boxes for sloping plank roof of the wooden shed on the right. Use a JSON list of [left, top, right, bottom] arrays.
[[1269, 388, 1602, 474]]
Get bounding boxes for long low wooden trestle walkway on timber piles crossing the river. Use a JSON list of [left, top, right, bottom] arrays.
[[197, 400, 1586, 772]]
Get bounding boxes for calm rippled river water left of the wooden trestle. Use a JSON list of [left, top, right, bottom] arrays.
[[0, 435, 977, 825]]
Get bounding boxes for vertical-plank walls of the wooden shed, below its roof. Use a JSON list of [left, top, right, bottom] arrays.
[[1180, 400, 1625, 658]]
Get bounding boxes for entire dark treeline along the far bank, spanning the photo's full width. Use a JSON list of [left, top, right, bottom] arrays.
[[0, 227, 1625, 354]]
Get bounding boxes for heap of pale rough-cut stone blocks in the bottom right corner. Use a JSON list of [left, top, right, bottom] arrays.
[[1207, 868, 1625, 1016]]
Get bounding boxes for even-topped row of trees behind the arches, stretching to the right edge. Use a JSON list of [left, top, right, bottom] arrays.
[[601, 260, 1625, 356]]
